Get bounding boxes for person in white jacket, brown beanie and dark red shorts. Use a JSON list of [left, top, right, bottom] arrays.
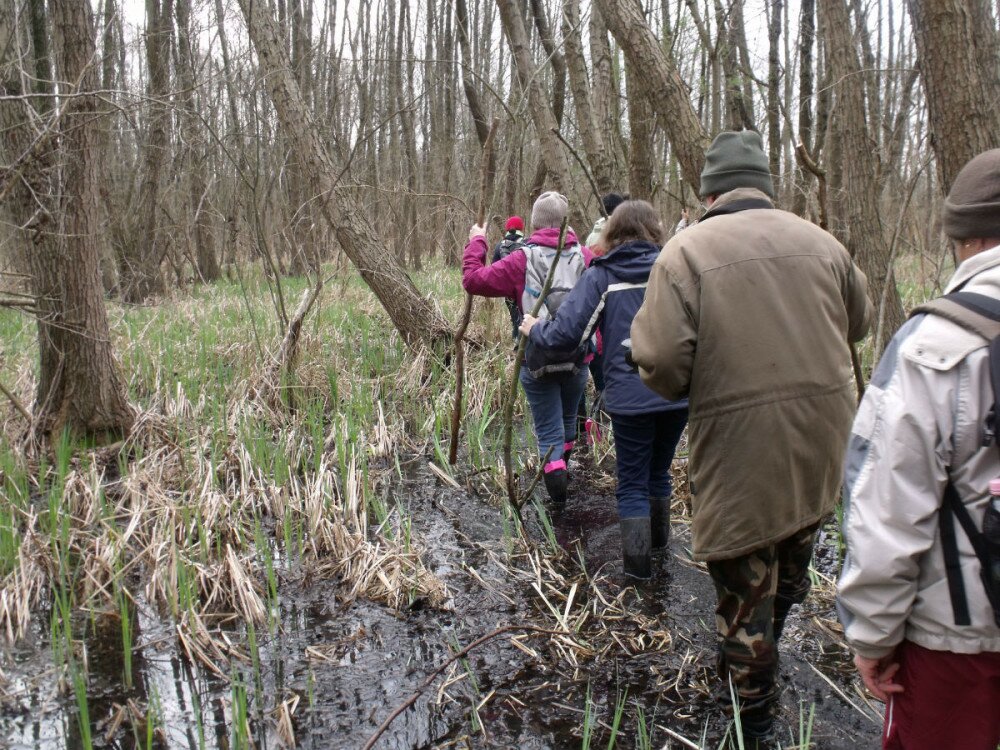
[[837, 149, 1000, 750]]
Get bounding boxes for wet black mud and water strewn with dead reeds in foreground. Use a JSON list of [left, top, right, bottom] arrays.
[[0, 456, 879, 750]]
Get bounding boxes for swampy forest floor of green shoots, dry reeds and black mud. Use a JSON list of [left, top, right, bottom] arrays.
[[0, 275, 880, 750]]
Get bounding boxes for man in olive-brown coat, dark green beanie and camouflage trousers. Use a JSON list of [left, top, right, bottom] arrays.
[[631, 131, 872, 747]]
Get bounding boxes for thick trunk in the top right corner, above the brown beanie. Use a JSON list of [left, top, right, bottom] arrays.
[[907, 0, 1000, 193]]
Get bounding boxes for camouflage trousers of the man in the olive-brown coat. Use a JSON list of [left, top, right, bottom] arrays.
[[708, 524, 819, 719]]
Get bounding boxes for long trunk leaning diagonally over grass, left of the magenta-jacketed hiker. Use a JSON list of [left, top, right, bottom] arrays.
[[239, 0, 449, 344]]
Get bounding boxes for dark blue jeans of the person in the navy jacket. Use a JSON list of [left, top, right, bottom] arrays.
[[611, 409, 687, 518]]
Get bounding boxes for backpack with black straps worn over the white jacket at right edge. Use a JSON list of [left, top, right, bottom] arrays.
[[911, 291, 1000, 627]]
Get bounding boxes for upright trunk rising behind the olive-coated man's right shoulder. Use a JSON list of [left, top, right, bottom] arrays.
[[819, 0, 905, 349]]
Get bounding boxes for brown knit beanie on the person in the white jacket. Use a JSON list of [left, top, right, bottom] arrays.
[[943, 148, 1000, 240]]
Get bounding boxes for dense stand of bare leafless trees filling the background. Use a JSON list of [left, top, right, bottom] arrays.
[[0, 0, 1000, 438]]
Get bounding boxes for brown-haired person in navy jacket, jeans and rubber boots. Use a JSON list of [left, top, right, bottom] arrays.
[[520, 200, 687, 579]]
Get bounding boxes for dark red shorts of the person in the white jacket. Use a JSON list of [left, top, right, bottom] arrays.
[[882, 641, 1000, 750]]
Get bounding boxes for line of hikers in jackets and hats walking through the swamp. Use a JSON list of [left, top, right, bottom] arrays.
[[462, 131, 1000, 750]]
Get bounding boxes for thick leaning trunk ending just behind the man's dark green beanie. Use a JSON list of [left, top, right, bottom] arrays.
[[595, 0, 708, 193]]
